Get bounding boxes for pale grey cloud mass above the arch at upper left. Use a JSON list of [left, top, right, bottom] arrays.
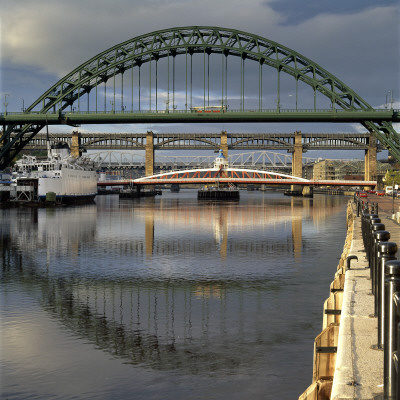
[[2, 0, 280, 77]]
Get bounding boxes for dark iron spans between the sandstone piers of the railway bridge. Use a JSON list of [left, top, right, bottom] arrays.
[[20, 132, 384, 152]]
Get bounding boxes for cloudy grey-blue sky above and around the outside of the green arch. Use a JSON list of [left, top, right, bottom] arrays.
[[0, 0, 400, 159]]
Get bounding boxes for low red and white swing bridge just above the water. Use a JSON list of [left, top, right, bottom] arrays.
[[132, 167, 376, 187]]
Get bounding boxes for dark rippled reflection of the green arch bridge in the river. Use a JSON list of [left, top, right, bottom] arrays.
[[0, 236, 296, 374]]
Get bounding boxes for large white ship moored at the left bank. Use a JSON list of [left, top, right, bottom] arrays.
[[13, 143, 97, 204]]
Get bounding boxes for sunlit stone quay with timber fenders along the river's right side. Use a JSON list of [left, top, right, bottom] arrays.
[[299, 195, 400, 400]]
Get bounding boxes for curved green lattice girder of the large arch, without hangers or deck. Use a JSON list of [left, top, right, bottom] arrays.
[[0, 26, 400, 169]]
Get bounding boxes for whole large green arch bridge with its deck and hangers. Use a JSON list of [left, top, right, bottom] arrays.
[[0, 26, 400, 169]]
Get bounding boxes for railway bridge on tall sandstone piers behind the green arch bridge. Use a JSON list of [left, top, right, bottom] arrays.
[[73, 131, 383, 181]]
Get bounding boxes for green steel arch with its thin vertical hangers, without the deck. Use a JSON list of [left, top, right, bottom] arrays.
[[0, 26, 400, 169]]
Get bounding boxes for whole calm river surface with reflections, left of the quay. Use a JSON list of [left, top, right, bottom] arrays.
[[0, 190, 347, 400]]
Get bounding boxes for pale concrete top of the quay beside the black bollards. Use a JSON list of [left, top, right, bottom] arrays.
[[331, 196, 400, 400]]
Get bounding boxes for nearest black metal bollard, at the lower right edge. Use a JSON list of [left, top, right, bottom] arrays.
[[383, 260, 400, 399]]
